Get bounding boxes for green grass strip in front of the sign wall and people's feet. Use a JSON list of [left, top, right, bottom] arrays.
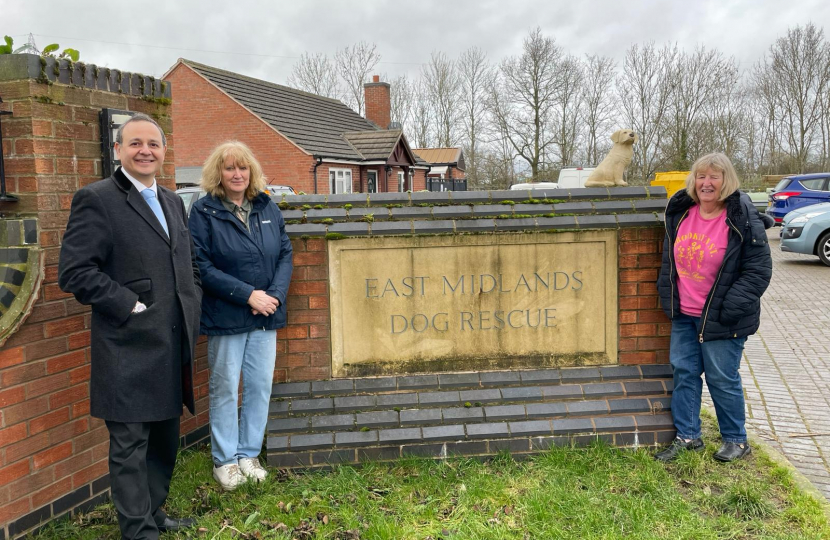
[[37, 420, 830, 540]]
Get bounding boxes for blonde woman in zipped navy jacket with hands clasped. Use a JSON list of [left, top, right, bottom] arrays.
[[190, 141, 293, 491]]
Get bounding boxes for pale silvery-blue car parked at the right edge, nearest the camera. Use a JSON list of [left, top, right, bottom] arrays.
[[781, 203, 830, 266]]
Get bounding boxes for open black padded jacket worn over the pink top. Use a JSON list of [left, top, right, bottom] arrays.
[[657, 190, 772, 343]]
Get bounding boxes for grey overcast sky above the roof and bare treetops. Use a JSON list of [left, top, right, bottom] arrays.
[[0, 0, 830, 85]]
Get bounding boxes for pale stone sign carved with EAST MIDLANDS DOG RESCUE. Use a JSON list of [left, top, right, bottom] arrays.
[[329, 231, 617, 377]]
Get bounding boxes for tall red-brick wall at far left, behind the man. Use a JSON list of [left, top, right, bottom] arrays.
[[0, 74, 207, 538]]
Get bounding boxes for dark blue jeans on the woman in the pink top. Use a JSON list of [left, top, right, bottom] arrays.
[[669, 314, 746, 443]]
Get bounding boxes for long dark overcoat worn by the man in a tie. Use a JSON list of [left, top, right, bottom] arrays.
[[58, 169, 202, 422]]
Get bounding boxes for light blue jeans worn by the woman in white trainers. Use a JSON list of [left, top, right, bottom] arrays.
[[208, 329, 277, 467]]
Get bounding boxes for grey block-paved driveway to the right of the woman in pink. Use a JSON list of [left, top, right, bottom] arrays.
[[707, 227, 830, 499]]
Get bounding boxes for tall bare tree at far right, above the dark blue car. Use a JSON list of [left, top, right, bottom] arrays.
[[759, 23, 830, 172]]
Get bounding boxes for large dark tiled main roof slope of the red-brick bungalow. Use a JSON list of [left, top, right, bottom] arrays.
[[180, 59, 382, 160]]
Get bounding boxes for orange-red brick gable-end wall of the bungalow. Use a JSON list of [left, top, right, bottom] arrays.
[[165, 64, 316, 193]]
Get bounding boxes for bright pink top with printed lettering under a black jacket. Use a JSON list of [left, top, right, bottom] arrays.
[[674, 205, 729, 317]]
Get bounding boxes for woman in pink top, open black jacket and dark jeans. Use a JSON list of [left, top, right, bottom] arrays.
[[655, 153, 772, 461]]
